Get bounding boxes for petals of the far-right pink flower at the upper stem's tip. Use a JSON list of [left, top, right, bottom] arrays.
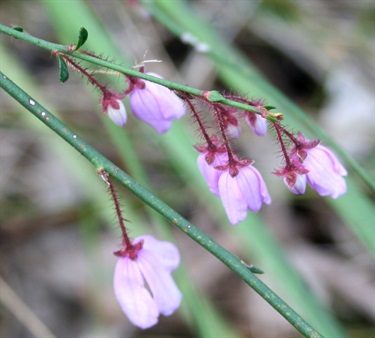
[[303, 144, 348, 198]]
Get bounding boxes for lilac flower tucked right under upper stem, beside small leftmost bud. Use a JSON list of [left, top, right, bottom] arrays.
[[130, 73, 186, 134]]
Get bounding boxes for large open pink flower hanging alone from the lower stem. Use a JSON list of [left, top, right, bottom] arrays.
[[114, 235, 182, 329]]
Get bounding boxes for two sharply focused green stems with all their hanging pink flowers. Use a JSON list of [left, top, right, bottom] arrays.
[[0, 26, 352, 336]]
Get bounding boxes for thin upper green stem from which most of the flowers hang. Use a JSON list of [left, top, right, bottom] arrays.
[[0, 24, 277, 117]]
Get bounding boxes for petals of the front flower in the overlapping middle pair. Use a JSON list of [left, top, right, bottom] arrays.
[[218, 165, 271, 225]]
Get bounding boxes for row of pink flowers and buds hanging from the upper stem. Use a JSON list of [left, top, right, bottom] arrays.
[[102, 69, 347, 225]]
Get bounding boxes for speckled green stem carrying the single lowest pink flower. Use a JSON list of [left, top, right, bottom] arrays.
[[0, 72, 322, 337]]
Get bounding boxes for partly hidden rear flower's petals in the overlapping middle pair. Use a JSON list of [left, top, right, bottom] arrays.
[[197, 153, 228, 196]]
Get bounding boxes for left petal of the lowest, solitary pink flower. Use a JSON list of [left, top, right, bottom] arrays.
[[113, 257, 159, 329]]
